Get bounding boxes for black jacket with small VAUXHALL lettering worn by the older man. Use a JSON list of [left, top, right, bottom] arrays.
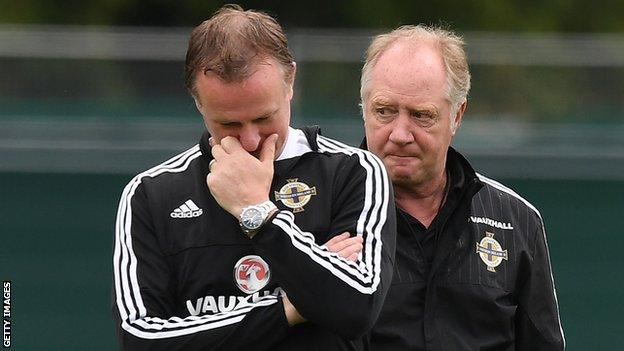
[[363, 144, 564, 351]]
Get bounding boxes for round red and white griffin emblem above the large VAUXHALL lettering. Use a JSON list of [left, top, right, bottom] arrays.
[[234, 255, 271, 294]]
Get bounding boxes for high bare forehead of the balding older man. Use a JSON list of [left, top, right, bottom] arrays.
[[369, 41, 446, 103]]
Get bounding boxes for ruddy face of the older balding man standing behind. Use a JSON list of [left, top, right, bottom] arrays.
[[362, 42, 465, 187]]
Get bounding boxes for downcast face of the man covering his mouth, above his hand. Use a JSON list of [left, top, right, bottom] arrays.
[[195, 60, 293, 157]]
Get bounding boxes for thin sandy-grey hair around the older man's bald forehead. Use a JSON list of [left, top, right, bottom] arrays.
[[360, 25, 470, 114]]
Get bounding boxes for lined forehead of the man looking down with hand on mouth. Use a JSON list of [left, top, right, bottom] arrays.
[[196, 62, 286, 119]]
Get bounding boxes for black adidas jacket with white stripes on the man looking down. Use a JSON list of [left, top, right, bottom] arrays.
[[113, 128, 395, 351]]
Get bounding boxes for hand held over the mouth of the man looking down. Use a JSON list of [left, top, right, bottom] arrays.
[[206, 134, 277, 218]]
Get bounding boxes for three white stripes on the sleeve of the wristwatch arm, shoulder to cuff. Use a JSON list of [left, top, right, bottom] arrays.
[[273, 136, 390, 294]]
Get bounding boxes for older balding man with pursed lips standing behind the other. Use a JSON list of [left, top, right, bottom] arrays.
[[361, 26, 565, 350]]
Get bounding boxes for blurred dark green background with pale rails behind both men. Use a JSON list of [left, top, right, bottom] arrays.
[[0, 0, 624, 350]]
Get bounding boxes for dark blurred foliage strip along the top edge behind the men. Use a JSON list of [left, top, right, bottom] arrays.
[[0, 0, 624, 32]]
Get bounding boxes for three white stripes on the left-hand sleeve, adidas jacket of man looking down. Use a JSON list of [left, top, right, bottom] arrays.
[[113, 145, 278, 339]]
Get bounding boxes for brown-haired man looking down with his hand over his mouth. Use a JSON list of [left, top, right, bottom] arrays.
[[113, 5, 395, 351]]
